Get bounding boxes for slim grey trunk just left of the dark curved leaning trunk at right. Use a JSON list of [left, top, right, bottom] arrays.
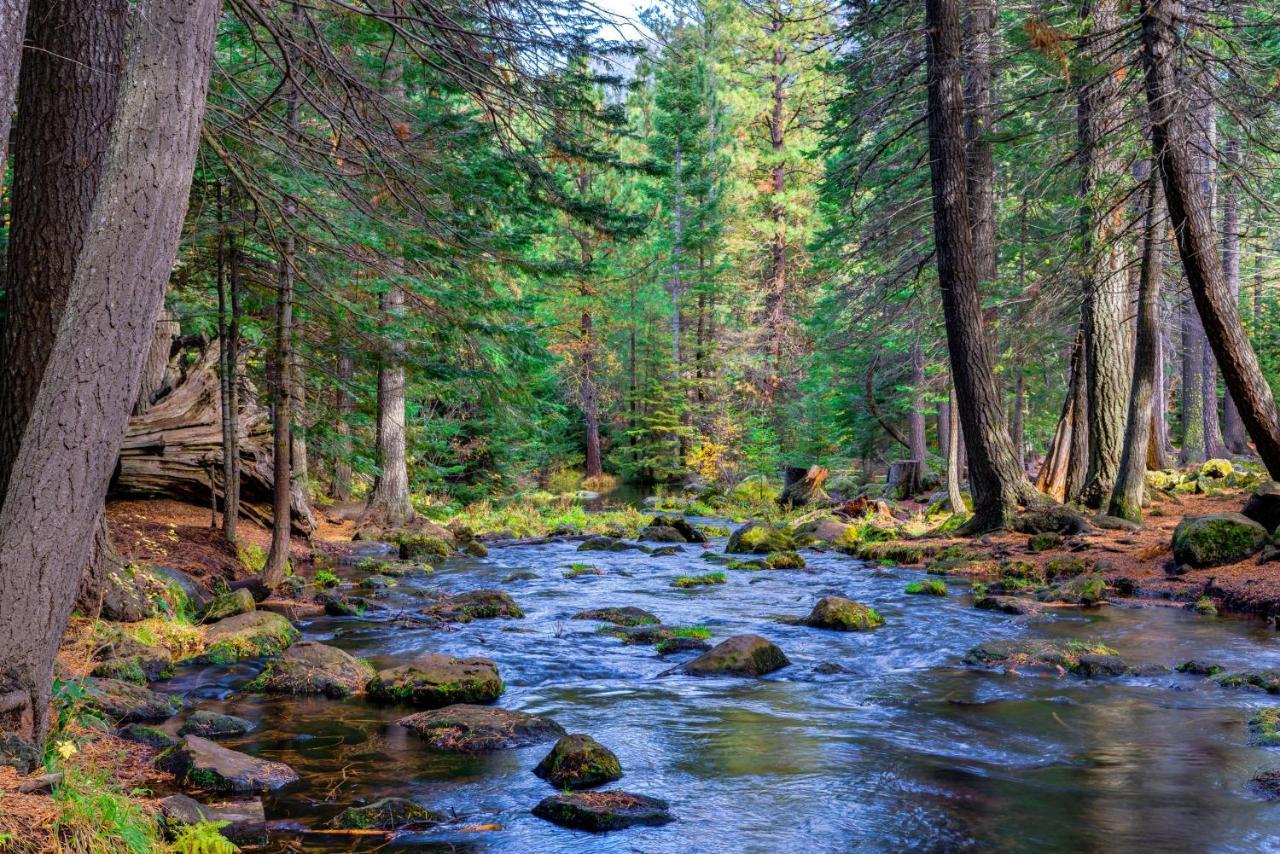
[[1107, 174, 1165, 522]]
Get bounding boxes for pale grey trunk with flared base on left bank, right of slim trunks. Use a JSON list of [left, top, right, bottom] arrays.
[[365, 283, 413, 529]]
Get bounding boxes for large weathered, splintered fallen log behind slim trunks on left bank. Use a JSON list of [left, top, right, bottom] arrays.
[[111, 341, 315, 535]]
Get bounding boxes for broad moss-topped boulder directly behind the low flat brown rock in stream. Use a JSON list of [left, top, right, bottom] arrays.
[[365, 653, 503, 709]]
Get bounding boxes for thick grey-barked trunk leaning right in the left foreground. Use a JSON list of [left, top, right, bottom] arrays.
[[0, 0, 220, 744]]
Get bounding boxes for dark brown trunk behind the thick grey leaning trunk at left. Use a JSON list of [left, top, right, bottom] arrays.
[[0, 0, 132, 495]]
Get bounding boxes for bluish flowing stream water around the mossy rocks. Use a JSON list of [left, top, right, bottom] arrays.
[[161, 530, 1280, 851]]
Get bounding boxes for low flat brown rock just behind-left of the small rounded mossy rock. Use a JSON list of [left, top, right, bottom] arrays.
[[397, 703, 564, 753]]
